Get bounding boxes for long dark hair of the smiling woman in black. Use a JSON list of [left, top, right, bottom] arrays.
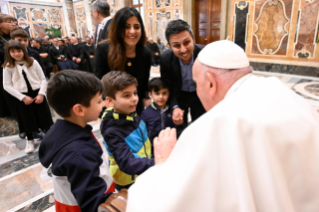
[[107, 7, 146, 71]]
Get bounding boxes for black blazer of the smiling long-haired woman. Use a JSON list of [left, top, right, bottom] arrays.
[[94, 42, 152, 101]]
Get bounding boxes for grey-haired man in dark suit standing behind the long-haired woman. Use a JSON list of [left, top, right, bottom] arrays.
[[92, 0, 112, 45]]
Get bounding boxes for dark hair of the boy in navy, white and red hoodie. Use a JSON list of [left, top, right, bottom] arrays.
[[47, 70, 103, 118]]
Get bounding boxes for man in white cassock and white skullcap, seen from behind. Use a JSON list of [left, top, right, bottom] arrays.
[[127, 41, 319, 212]]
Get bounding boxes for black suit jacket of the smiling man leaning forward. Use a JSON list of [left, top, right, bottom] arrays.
[[160, 44, 204, 107]]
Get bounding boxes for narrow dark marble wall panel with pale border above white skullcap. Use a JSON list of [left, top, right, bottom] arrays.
[[233, 1, 249, 50]]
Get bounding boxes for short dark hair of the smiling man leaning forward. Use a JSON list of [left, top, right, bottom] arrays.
[[165, 19, 194, 45]]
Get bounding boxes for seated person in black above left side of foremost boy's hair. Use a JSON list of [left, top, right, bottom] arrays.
[[49, 38, 78, 70]]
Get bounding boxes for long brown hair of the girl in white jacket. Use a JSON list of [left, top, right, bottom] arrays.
[[2, 40, 33, 68]]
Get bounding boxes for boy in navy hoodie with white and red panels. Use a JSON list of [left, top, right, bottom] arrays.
[[39, 70, 114, 212]]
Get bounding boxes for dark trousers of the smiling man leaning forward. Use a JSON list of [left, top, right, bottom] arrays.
[[177, 91, 206, 130]]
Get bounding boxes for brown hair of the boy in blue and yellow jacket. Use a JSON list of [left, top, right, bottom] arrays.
[[102, 71, 138, 99]]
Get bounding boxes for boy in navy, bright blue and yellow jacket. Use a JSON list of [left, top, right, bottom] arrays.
[[100, 71, 154, 190]]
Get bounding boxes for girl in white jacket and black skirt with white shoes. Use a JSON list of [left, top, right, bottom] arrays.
[[3, 40, 53, 153]]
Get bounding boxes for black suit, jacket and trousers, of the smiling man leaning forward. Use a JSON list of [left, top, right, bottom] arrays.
[[160, 44, 205, 126]]
